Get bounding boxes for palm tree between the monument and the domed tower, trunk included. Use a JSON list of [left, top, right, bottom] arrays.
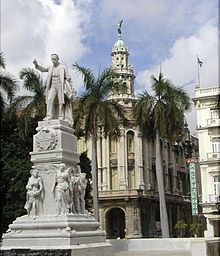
[[73, 63, 126, 220]]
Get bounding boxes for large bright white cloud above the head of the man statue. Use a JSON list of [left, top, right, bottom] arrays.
[[1, 0, 90, 93]]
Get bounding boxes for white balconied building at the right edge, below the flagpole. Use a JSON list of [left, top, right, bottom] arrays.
[[194, 86, 220, 237]]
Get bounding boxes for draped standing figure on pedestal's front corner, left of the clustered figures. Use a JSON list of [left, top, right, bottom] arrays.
[[52, 164, 71, 215]]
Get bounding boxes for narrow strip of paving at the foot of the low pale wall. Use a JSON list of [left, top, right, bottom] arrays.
[[113, 251, 191, 256]]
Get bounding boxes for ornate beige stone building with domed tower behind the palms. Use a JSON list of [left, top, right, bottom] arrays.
[[78, 28, 198, 238]]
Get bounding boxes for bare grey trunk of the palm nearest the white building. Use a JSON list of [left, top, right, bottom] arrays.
[[156, 132, 169, 238]]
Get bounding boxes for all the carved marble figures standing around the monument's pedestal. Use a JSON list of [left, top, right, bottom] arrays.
[[24, 163, 87, 219]]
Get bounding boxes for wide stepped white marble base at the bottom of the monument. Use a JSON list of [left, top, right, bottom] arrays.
[[1, 214, 112, 256]]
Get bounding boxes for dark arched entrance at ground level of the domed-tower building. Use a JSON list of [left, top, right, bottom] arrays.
[[105, 207, 125, 239]]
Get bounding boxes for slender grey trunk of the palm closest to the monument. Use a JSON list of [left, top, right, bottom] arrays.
[[92, 134, 99, 221]]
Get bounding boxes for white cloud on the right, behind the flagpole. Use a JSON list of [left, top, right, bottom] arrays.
[[136, 21, 219, 133]]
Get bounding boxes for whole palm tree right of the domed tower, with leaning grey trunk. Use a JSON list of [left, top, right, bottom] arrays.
[[134, 73, 190, 237]]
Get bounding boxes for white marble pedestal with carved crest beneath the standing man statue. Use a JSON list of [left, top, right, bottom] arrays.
[[1, 120, 112, 256]]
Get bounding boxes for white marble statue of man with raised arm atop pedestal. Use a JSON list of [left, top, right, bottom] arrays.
[[33, 53, 75, 124]]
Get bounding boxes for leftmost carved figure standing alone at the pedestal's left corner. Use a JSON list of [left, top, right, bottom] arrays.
[[24, 167, 43, 219]]
